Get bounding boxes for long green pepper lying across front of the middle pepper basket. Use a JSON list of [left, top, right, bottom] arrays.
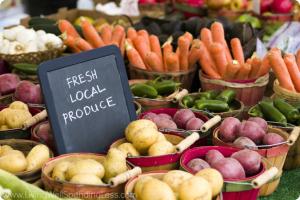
[[195, 100, 229, 112]]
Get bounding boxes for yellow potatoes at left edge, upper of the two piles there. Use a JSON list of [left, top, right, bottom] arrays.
[[0, 101, 32, 130]]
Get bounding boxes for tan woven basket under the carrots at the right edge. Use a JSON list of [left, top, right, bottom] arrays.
[[273, 79, 300, 105]]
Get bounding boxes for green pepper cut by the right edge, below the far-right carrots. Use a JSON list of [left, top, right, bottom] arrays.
[[273, 98, 300, 123]]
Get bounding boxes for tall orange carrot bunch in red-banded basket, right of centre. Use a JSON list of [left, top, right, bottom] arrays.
[[199, 22, 270, 81]]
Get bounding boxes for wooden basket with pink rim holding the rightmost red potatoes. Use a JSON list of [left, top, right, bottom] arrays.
[[213, 126, 296, 196]]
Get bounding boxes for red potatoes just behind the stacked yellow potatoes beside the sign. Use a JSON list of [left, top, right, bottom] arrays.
[[143, 109, 204, 130]]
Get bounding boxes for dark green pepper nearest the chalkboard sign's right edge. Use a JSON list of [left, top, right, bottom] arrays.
[[130, 83, 158, 99]]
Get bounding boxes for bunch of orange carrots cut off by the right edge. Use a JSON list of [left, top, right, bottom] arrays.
[[266, 48, 300, 93]]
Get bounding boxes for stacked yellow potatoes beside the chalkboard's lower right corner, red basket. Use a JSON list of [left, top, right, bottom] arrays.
[[121, 119, 176, 156]]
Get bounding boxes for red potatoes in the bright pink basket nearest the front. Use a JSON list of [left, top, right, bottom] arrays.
[[187, 149, 261, 179]]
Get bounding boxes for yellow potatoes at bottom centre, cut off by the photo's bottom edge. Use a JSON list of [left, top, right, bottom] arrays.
[[134, 169, 223, 200]]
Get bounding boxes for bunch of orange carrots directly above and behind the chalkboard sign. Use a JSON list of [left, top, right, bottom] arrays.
[[58, 19, 126, 54]]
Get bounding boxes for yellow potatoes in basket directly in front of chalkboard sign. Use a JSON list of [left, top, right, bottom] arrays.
[[51, 148, 128, 185]]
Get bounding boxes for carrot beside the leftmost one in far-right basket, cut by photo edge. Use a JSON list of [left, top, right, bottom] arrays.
[[284, 53, 300, 92]]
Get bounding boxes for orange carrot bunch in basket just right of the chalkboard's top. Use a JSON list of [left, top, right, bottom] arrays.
[[125, 28, 200, 72]]
